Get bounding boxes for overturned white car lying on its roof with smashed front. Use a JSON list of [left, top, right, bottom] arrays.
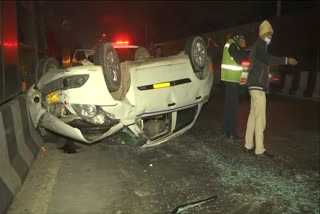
[[27, 37, 213, 147]]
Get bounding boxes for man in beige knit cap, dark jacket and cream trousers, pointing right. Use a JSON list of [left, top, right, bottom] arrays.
[[245, 20, 297, 157]]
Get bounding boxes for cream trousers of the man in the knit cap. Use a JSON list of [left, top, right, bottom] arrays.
[[245, 90, 266, 155]]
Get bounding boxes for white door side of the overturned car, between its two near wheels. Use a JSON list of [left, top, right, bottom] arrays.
[[130, 55, 213, 117]]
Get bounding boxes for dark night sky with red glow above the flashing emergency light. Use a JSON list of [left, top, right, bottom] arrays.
[[46, 1, 320, 48]]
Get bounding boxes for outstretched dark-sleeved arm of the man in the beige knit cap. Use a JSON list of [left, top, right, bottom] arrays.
[[256, 41, 289, 65]]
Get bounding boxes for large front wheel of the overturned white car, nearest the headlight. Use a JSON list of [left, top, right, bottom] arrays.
[[94, 43, 121, 92]]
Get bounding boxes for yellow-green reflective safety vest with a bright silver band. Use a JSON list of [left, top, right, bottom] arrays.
[[221, 39, 243, 83]]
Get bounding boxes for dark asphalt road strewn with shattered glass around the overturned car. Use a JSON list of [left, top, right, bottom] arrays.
[[8, 86, 320, 214]]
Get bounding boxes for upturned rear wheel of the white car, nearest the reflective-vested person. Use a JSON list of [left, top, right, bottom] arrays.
[[185, 36, 208, 73]]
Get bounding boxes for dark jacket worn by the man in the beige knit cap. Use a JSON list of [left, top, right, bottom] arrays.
[[247, 38, 288, 92]]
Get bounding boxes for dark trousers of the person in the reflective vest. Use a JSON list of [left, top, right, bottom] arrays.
[[224, 82, 240, 136]]
